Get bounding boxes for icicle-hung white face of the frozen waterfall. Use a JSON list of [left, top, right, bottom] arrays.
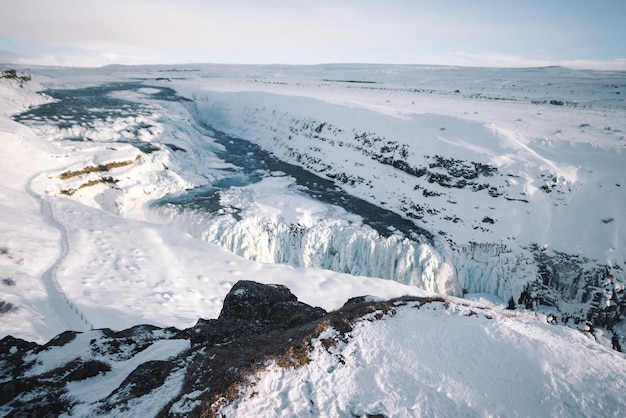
[[149, 205, 462, 295]]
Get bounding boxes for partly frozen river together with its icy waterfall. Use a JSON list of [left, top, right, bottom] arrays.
[[15, 82, 443, 290]]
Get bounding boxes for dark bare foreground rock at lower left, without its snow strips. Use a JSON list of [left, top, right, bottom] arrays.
[[0, 281, 327, 417]]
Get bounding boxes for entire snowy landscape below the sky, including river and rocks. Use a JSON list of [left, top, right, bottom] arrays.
[[0, 65, 626, 417]]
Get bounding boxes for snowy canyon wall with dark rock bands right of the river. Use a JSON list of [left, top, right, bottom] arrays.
[[194, 92, 626, 350]]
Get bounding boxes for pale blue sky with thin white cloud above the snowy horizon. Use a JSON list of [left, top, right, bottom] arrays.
[[0, 0, 626, 69]]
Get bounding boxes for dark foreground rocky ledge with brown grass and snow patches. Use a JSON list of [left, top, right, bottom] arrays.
[[0, 281, 443, 417]]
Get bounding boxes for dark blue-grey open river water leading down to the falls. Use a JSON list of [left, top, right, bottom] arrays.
[[14, 81, 433, 242]]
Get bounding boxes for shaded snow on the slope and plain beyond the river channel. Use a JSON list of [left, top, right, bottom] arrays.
[[176, 67, 626, 306]]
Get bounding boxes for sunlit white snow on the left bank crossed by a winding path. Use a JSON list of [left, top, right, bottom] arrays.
[[0, 69, 434, 343]]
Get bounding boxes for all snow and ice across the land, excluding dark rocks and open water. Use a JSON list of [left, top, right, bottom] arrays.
[[0, 65, 626, 416]]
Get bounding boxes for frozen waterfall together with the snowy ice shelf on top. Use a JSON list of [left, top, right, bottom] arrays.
[[150, 177, 461, 294]]
